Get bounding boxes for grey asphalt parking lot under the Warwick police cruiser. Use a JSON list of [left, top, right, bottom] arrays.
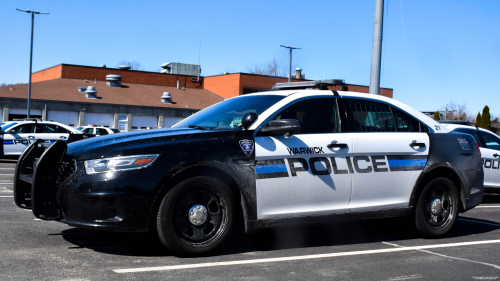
[[0, 160, 500, 280]]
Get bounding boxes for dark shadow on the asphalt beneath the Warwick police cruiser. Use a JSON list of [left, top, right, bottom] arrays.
[[58, 213, 500, 256]]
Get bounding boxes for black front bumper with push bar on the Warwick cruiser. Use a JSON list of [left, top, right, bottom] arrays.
[[14, 139, 163, 232]]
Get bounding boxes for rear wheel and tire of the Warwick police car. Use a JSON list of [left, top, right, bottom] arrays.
[[414, 177, 459, 237]]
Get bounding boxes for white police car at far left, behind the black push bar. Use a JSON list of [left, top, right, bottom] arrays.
[[0, 119, 81, 156]]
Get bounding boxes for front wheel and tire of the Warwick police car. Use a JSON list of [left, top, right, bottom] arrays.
[[156, 176, 235, 256]]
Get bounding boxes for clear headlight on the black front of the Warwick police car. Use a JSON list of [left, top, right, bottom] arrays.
[[84, 154, 158, 175]]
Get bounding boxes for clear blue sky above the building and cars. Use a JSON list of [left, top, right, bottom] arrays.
[[0, 0, 500, 115]]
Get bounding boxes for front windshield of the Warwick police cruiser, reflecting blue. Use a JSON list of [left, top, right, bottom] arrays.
[[175, 95, 285, 129]]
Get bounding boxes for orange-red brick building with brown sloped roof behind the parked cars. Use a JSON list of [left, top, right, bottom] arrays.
[[0, 64, 393, 131]]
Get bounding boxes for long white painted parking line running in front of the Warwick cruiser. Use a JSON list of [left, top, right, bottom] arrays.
[[113, 237, 500, 273]]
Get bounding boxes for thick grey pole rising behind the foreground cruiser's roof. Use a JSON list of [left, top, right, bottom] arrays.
[[370, 0, 384, 95]]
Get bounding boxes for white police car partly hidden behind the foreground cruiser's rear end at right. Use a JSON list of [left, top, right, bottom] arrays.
[[440, 120, 500, 193]]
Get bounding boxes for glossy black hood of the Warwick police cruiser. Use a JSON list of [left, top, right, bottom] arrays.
[[66, 128, 213, 160]]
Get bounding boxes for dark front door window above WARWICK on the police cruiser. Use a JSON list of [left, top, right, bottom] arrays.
[[273, 98, 340, 134]]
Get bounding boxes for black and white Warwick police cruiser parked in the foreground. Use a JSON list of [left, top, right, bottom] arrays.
[[14, 80, 483, 255]]
